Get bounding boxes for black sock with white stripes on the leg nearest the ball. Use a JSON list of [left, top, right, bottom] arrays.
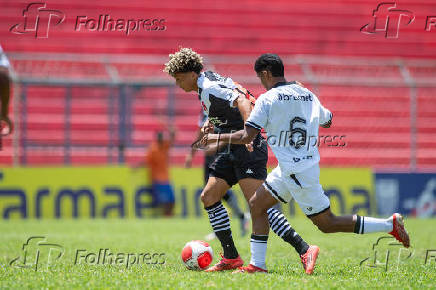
[[205, 201, 239, 259]]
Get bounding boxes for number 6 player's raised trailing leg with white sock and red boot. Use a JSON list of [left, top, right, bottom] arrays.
[[309, 208, 410, 248]]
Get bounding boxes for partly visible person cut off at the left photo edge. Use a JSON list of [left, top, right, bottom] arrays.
[[0, 46, 12, 134]]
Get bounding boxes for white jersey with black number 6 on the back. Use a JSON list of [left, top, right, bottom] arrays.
[[245, 82, 332, 175]]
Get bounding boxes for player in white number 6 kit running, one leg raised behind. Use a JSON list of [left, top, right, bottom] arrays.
[[202, 54, 410, 273]]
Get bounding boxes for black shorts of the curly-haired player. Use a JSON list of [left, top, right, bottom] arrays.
[[209, 134, 268, 186]]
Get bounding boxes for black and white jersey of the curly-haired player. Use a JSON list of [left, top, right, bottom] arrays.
[[197, 71, 244, 133]]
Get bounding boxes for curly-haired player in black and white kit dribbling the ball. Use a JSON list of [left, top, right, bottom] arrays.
[[164, 48, 317, 272]]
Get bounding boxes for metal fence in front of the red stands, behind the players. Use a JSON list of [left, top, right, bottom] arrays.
[[1, 53, 436, 170]]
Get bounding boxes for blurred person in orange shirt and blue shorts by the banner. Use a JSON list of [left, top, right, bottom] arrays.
[[146, 128, 175, 216]]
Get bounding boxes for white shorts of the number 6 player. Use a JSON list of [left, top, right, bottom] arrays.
[[263, 163, 330, 217]]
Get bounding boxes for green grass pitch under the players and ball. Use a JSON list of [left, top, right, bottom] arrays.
[[0, 218, 436, 289]]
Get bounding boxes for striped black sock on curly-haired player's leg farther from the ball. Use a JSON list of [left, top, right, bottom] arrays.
[[267, 208, 309, 256]]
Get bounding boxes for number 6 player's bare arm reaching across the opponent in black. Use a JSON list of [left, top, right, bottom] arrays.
[[202, 126, 260, 146]]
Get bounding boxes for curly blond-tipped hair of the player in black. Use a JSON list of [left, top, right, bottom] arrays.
[[163, 47, 203, 77]]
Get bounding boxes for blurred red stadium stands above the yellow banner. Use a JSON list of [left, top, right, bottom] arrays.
[[0, 0, 436, 170]]
